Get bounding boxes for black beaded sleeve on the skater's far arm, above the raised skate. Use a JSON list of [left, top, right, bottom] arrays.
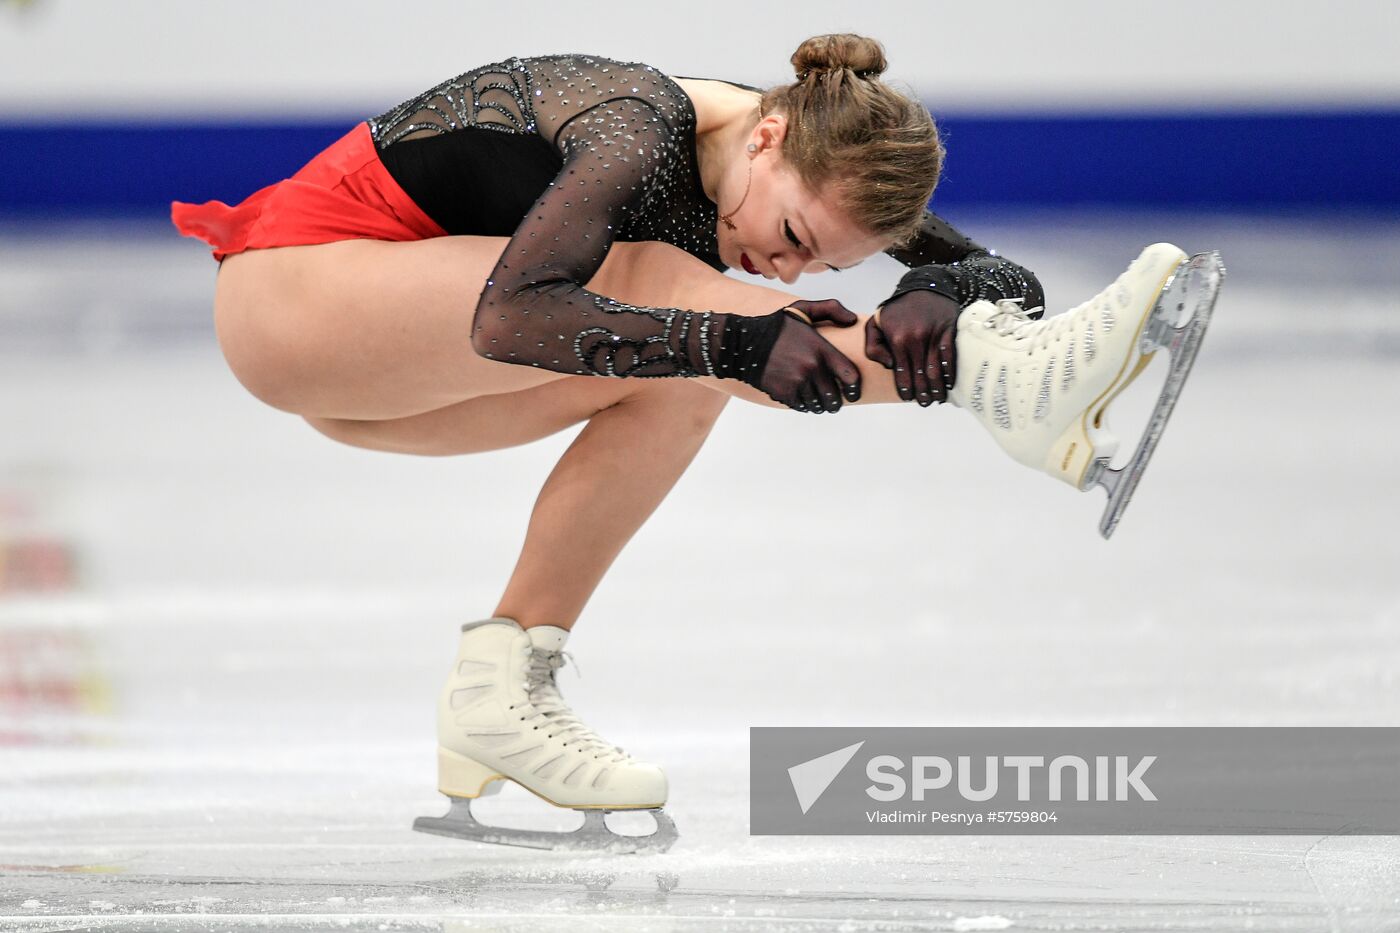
[[885, 210, 1046, 317]]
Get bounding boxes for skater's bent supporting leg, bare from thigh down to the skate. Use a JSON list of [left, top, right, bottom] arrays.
[[307, 375, 729, 629]]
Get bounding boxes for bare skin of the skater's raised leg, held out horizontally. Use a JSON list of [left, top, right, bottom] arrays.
[[214, 237, 899, 420]]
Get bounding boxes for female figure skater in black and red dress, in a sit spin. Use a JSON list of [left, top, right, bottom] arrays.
[[174, 35, 1204, 849]]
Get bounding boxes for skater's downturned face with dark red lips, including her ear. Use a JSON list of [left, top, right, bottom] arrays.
[[715, 113, 890, 284]]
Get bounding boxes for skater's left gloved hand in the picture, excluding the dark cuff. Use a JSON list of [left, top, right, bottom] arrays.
[[757, 298, 861, 415]]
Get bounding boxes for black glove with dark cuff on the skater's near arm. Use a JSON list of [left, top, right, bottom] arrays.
[[714, 298, 861, 415]]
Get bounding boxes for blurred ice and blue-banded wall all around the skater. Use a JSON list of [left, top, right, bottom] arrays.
[[0, 0, 1400, 930]]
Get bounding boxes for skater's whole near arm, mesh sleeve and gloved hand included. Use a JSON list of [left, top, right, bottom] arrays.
[[472, 98, 860, 410]]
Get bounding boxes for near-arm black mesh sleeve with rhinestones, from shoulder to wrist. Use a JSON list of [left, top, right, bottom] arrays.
[[472, 98, 732, 377]]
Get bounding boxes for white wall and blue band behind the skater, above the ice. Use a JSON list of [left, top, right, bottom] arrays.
[[0, 0, 1400, 216]]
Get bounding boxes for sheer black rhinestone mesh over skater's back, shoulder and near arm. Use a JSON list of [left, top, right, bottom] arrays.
[[371, 56, 724, 377]]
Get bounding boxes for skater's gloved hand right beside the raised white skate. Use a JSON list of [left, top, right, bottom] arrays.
[[865, 290, 962, 408]]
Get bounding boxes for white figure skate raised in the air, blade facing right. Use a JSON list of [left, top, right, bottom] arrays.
[[951, 242, 1225, 538]]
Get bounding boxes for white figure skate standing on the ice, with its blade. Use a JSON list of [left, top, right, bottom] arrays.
[[413, 618, 676, 852]]
